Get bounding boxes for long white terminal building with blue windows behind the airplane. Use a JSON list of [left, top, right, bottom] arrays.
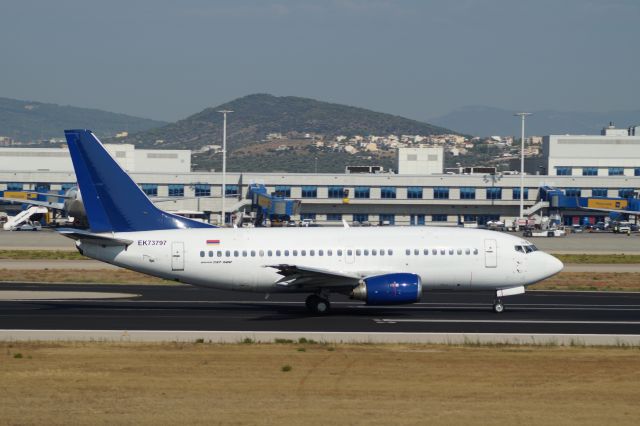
[[0, 126, 640, 225]]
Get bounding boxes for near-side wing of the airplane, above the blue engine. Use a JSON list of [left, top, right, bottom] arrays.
[[265, 264, 362, 288]]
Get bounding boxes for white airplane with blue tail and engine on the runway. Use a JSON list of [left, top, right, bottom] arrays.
[[58, 130, 563, 315]]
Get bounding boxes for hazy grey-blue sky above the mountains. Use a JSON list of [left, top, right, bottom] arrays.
[[0, 0, 640, 121]]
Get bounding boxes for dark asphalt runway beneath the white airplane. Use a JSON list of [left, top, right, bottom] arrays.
[[0, 284, 640, 336]]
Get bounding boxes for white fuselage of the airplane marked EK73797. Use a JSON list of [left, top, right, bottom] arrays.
[[78, 226, 562, 292]]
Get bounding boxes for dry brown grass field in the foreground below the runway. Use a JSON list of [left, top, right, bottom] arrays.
[[0, 343, 640, 425]]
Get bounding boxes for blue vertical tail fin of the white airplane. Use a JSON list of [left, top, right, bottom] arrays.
[[64, 130, 212, 232]]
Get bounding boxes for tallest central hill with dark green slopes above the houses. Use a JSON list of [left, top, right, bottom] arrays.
[[115, 94, 456, 150]]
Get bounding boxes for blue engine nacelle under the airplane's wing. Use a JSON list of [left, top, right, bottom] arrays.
[[351, 273, 422, 305]]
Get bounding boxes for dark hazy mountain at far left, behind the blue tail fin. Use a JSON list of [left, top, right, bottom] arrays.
[[0, 98, 166, 142]]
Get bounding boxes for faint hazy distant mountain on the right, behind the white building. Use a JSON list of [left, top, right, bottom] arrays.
[[429, 106, 640, 136]]
